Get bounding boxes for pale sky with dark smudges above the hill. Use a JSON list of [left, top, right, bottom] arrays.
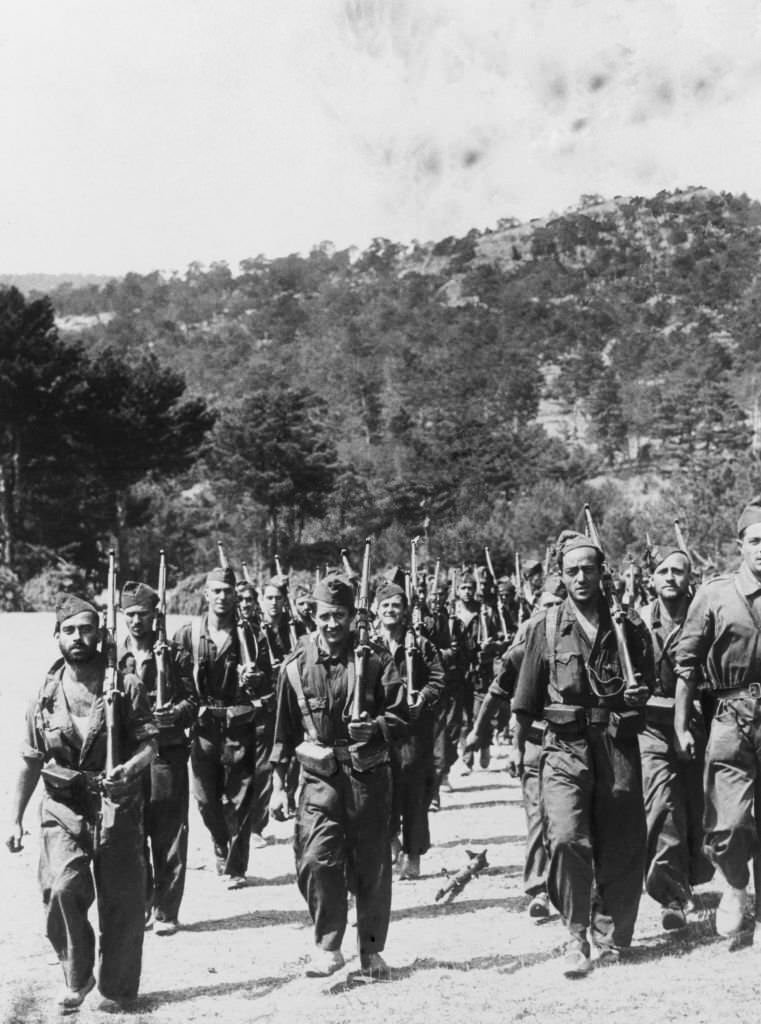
[[0, 0, 761, 274]]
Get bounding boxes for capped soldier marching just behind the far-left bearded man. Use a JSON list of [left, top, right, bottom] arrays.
[[119, 580, 198, 935]]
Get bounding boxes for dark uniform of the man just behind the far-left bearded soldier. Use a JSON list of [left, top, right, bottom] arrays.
[[119, 634, 198, 922]]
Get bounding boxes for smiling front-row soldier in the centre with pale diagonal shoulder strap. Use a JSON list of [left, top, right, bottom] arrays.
[[270, 575, 408, 977]]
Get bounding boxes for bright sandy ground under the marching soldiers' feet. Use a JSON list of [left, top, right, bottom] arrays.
[[0, 614, 761, 1024]]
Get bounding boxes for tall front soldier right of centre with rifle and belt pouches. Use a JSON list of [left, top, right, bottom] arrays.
[[513, 531, 652, 978]]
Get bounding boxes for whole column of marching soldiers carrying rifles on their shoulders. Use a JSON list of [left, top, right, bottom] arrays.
[[7, 493, 761, 1013]]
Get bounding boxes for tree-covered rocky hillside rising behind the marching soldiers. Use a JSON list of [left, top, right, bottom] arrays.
[[7, 188, 761, 581]]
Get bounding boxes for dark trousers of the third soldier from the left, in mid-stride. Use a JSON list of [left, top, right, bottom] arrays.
[[191, 720, 256, 876]]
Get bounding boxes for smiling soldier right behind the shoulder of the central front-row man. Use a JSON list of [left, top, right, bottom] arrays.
[[375, 583, 443, 879]]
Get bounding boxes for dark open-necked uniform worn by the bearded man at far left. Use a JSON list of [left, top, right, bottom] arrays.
[[22, 659, 158, 1001]]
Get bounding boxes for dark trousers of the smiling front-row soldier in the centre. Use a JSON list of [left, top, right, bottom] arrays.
[[294, 762, 391, 953]]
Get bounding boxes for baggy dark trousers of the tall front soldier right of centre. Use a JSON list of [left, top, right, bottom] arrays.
[[541, 725, 645, 947]]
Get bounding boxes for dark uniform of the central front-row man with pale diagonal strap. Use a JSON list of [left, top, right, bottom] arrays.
[[271, 637, 408, 955]]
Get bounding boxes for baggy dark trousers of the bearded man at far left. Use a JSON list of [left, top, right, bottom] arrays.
[[39, 795, 145, 999]]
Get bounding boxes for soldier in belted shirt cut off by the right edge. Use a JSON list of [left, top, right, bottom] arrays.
[[674, 496, 761, 950]]
